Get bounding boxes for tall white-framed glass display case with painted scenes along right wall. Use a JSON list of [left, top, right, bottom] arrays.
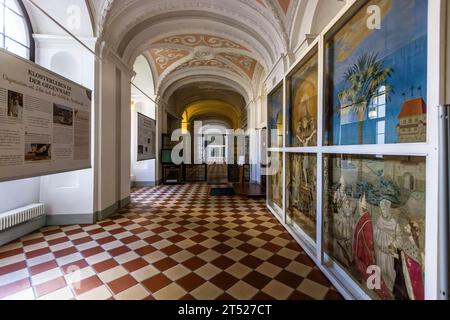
[[267, 0, 445, 300]]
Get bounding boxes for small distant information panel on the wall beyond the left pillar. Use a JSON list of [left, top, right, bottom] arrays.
[[137, 113, 156, 161]]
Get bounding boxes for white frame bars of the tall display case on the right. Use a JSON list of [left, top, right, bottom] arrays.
[[267, 0, 448, 299]]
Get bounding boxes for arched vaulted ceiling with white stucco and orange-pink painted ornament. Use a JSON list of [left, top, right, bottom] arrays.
[[87, 0, 348, 102]]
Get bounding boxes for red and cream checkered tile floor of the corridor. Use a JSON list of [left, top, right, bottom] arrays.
[[0, 184, 341, 300]]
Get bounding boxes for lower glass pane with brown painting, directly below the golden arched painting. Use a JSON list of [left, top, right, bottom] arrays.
[[286, 154, 317, 241]]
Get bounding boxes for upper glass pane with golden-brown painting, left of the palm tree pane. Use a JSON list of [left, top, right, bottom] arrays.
[[286, 54, 318, 147]]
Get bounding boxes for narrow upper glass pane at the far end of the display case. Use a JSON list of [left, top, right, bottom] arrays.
[[269, 86, 284, 148]]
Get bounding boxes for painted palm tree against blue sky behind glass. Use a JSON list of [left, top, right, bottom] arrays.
[[338, 53, 394, 144]]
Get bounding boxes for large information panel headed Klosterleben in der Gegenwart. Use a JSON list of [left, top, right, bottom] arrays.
[[0, 49, 92, 181]]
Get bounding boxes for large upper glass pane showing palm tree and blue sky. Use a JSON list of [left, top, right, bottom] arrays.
[[324, 0, 428, 145]]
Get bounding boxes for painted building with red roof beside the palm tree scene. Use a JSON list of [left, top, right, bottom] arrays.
[[397, 97, 427, 143]]
